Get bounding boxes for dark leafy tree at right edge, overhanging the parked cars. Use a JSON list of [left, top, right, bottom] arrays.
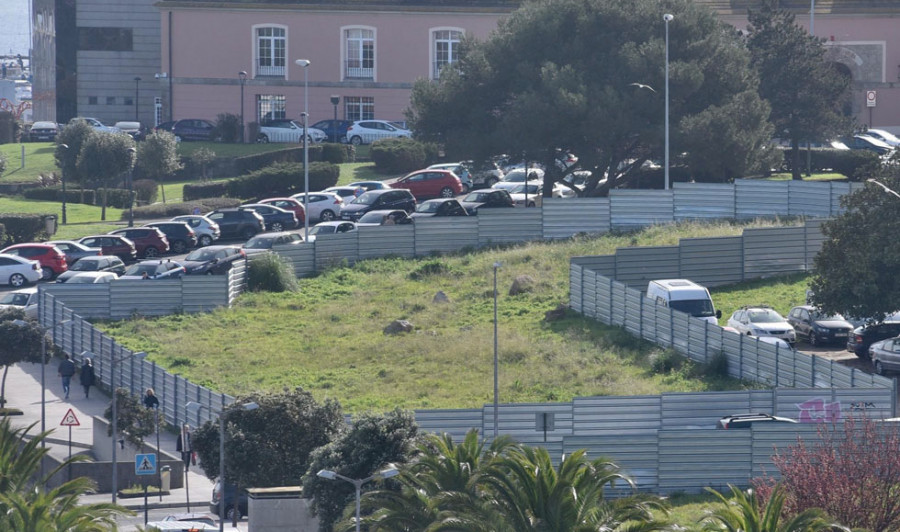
[[810, 173, 900, 320]]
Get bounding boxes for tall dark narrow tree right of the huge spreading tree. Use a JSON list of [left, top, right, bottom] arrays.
[[747, 0, 853, 179]]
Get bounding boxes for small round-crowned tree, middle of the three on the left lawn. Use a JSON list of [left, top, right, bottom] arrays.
[[77, 133, 135, 220]]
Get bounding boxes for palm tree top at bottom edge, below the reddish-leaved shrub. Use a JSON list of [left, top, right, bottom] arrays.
[[701, 484, 850, 532]]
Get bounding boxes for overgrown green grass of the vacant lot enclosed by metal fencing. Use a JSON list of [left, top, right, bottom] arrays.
[[100, 218, 800, 412]]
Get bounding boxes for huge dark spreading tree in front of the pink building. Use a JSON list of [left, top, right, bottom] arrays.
[[407, 0, 774, 195]]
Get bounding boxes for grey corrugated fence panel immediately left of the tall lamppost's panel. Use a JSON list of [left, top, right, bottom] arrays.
[[543, 198, 610, 238]]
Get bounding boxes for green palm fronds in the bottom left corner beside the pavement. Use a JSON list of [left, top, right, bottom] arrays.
[[0, 418, 133, 532]]
